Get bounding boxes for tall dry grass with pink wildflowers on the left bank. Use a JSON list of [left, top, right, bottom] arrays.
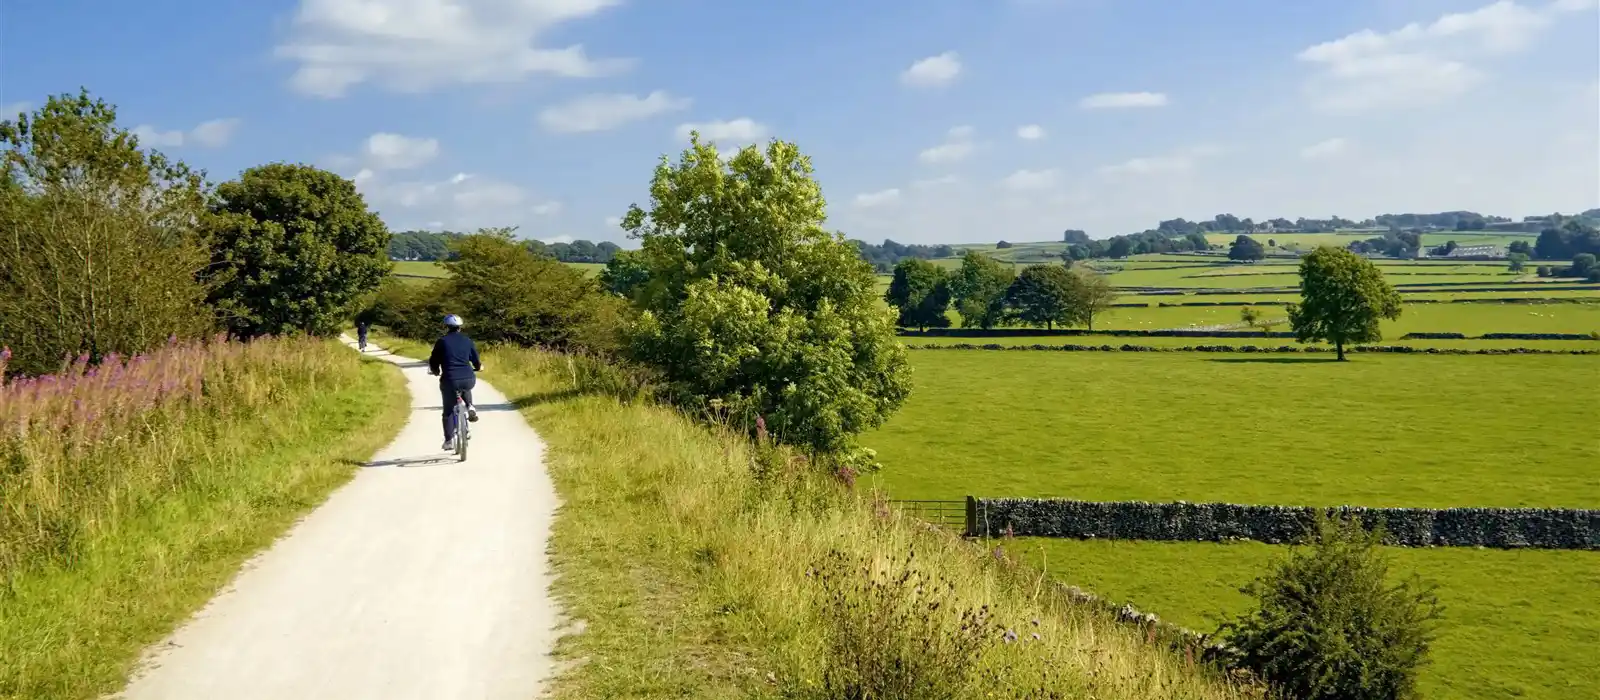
[[0, 339, 360, 595]]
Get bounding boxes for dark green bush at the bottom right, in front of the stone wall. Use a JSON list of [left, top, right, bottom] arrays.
[[1221, 515, 1440, 700]]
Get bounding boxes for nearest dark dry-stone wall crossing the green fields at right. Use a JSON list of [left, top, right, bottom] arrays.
[[970, 499, 1600, 550]]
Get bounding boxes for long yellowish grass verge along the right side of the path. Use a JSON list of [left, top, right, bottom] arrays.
[[368, 334, 1240, 698]]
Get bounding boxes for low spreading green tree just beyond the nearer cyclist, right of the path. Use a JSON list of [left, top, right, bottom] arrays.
[[451, 229, 624, 353]]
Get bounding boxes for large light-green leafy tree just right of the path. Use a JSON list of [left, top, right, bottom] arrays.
[[622, 134, 910, 454]]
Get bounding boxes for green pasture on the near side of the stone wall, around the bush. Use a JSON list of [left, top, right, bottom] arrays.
[[1008, 539, 1600, 700]]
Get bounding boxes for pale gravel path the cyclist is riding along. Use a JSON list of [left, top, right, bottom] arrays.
[[117, 338, 560, 700]]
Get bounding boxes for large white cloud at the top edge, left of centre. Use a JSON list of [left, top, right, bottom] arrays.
[[277, 0, 630, 97]]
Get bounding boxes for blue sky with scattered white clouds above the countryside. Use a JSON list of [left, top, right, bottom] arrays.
[[0, 0, 1600, 243]]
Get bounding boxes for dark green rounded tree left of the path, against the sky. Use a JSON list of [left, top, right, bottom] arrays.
[[206, 163, 390, 337]]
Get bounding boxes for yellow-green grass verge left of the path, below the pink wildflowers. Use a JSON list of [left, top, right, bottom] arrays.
[[0, 342, 410, 700]]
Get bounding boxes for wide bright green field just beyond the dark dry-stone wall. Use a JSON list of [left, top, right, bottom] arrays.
[[866, 350, 1600, 507]]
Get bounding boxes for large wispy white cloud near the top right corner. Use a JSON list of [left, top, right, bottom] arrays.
[[1296, 0, 1594, 112]]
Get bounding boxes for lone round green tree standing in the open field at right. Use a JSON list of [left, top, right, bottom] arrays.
[[1290, 248, 1400, 361]]
